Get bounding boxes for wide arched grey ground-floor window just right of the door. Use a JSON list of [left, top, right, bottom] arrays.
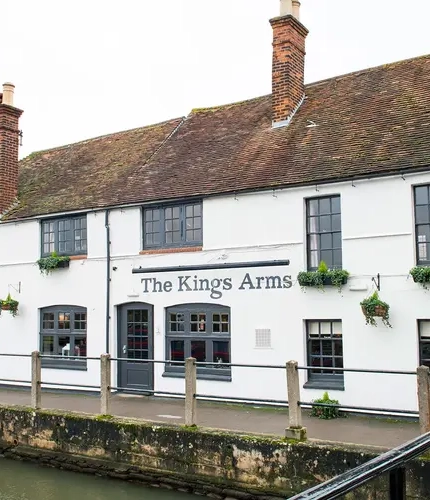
[[166, 304, 231, 380]]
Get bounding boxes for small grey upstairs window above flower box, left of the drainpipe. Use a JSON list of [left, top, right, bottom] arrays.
[[42, 215, 87, 257]]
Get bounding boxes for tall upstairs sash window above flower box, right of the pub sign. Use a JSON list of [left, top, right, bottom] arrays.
[[306, 196, 342, 271]]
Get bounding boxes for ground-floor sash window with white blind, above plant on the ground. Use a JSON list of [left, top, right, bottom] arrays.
[[306, 320, 343, 389]]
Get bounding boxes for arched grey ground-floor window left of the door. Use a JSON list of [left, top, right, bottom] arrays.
[[40, 306, 87, 369]]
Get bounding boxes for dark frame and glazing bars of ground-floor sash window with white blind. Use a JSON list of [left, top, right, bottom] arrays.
[[304, 319, 345, 390]]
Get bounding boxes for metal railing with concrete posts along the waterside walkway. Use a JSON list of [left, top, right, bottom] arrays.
[[0, 351, 430, 439]]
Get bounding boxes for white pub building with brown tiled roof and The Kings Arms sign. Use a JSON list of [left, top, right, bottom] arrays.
[[0, 0, 430, 410]]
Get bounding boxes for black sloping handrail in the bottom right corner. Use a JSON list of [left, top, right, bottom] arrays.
[[289, 432, 430, 500]]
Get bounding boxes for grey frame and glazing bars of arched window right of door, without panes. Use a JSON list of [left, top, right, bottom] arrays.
[[163, 303, 231, 382]]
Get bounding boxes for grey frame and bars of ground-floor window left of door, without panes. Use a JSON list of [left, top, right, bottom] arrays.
[[39, 305, 88, 370]]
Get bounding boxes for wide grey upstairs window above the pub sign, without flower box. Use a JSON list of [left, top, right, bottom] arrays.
[[143, 202, 203, 248]]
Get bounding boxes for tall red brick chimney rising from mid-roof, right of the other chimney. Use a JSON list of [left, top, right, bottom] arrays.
[[270, 0, 308, 127]]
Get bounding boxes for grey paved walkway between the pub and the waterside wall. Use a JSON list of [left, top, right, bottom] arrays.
[[0, 389, 419, 448]]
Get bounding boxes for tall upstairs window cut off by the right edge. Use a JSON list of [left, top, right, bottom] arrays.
[[414, 185, 430, 266]]
